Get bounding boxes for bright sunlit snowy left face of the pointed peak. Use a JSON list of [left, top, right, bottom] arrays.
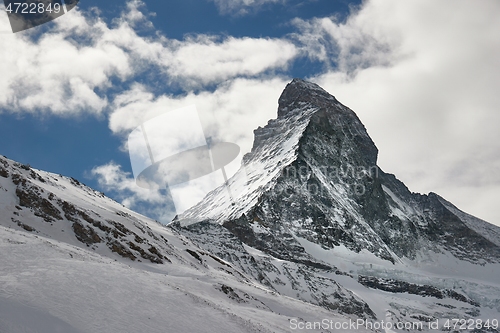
[[178, 106, 318, 225]]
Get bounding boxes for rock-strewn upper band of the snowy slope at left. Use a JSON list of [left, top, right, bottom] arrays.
[[0, 157, 243, 266]]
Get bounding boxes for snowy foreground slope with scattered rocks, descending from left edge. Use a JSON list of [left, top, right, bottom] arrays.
[[0, 157, 376, 333]]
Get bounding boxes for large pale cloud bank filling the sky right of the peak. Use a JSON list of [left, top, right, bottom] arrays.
[[296, 0, 500, 224]]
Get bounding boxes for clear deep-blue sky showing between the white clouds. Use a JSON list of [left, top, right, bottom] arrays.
[[0, 0, 357, 171]]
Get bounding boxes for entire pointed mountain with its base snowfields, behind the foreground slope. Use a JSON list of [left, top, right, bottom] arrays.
[[175, 79, 500, 332]]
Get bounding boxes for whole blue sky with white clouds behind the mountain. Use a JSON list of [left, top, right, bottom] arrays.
[[0, 0, 500, 224]]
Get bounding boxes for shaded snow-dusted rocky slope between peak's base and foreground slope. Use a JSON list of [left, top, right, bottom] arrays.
[[176, 222, 376, 319]]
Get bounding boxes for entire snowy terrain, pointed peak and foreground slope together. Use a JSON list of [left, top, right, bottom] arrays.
[[0, 79, 500, 333]]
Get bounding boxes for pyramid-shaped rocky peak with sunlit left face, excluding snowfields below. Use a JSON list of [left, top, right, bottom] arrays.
[[176, 79, 500, 263]]
